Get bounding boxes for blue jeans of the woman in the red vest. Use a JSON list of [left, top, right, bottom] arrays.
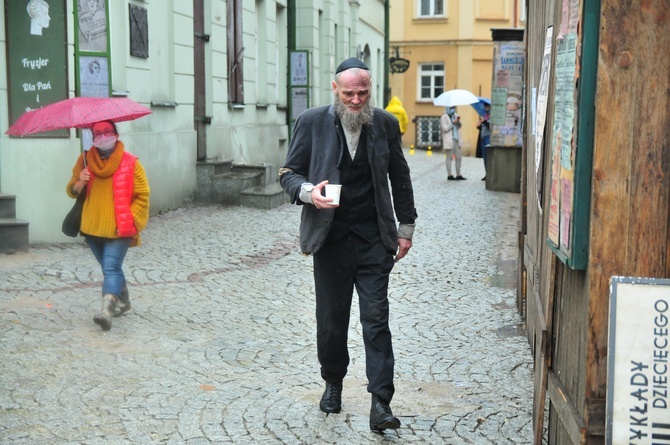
[[86, 235, 133, 297]]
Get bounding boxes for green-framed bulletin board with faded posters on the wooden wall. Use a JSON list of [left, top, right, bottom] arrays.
[[547, 0, 600, 269]]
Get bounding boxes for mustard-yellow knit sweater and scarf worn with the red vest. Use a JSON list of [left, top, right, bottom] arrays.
[[66, 141, 150, 246]]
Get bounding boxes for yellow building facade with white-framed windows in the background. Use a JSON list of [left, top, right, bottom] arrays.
[[389, 0, 525, 156]]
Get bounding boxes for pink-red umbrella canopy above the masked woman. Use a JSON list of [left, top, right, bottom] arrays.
[[5, 97, 151, 136]]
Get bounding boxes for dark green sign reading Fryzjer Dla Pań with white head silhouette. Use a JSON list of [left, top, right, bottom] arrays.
[[5, 0, 70, 137]]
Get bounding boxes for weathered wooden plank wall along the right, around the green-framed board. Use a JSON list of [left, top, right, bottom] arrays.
[[520, 0, 670, 445]]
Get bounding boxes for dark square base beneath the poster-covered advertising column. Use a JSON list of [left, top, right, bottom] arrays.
[[486, 145, 522, 193]]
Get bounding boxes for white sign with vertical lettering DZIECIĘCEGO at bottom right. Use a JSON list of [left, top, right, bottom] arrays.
[[605, 277, 670, 445]]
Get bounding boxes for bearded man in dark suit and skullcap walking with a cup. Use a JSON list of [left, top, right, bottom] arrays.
[[279, 58, 417, 431]]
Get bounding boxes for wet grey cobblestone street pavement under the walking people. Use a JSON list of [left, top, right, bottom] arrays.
[[0, 150, 533, 445]]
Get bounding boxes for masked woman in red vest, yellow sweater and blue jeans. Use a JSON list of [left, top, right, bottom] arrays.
[[67, 121, 149, 331]]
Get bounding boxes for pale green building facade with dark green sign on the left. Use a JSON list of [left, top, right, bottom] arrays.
[[0, 0, 386, 243]]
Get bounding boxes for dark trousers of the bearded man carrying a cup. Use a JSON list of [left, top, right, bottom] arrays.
[[314, 232, 395, 402]]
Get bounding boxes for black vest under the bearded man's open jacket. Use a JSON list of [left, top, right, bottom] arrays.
[[328, 129, 379, 242]]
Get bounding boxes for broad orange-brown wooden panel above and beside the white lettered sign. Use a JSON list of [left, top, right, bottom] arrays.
[[585, 0, 670, 438]]
